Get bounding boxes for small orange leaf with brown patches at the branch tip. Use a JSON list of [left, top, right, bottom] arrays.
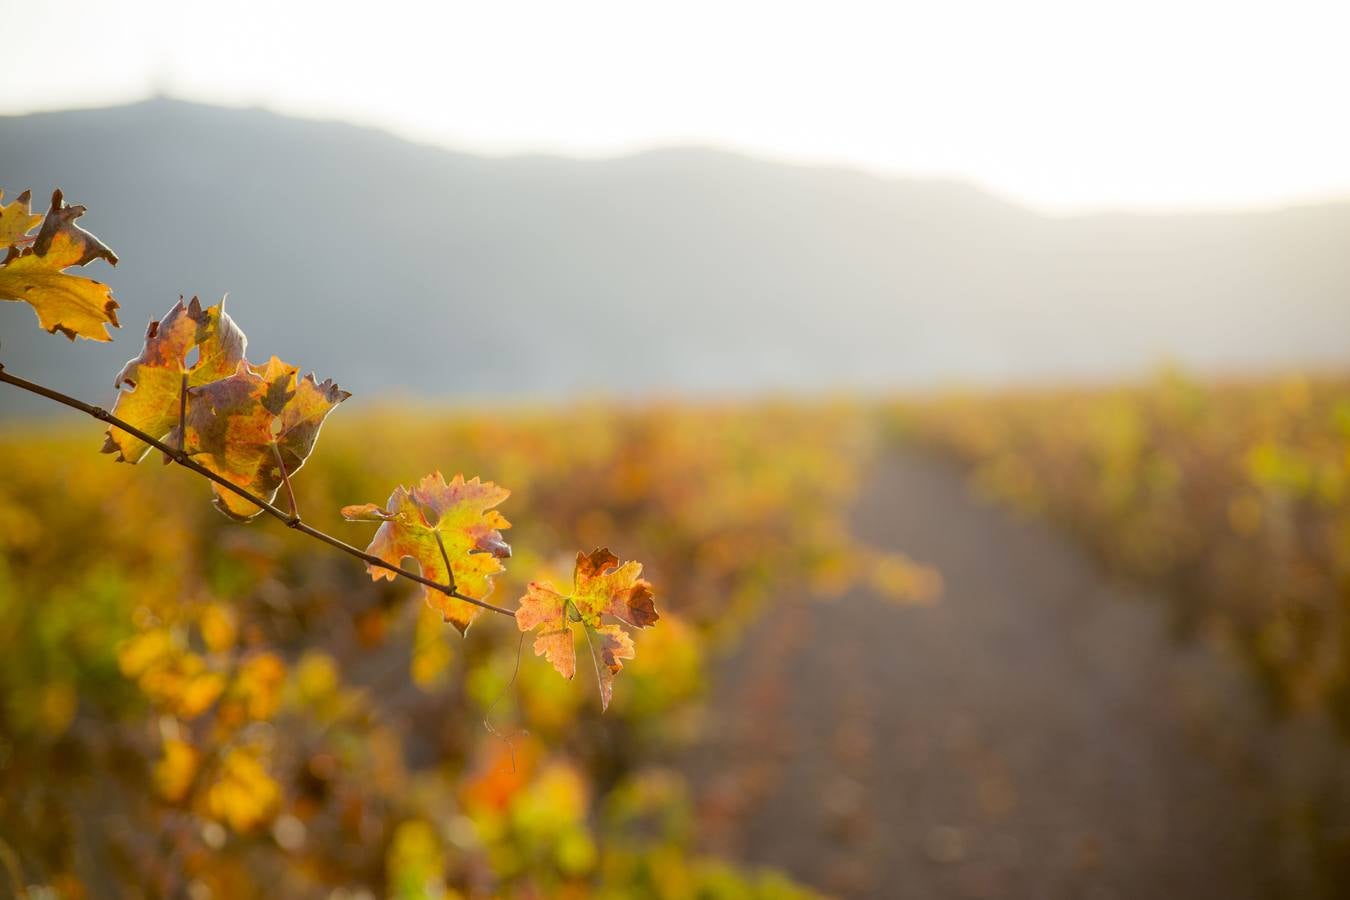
[[516, 548, 660, 710]]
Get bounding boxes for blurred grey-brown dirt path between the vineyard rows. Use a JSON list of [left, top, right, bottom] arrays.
[[689, 453, 1269, 900]]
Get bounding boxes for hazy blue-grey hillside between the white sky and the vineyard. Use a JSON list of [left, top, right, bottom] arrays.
[[0, 100, 1350, 410]]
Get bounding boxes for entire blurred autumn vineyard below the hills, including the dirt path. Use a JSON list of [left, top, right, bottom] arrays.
[[0, 372, 1350, 897]]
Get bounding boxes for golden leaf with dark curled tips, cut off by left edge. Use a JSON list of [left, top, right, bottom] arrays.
[[0, 190, 119, 340]]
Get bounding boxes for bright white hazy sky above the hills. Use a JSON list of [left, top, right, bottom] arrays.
[[10, 0, 1350, 210]]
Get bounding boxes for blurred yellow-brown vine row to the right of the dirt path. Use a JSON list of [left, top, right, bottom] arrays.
[[887, 370, 1350, 897]]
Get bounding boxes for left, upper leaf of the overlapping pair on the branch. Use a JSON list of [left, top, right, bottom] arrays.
[[103, 297, 247, 463]]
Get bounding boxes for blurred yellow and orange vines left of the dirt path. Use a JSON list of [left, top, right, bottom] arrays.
[[0, 405, 933, 897]]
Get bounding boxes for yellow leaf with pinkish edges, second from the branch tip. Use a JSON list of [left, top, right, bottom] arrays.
[[342, 472, 510, 633]]
